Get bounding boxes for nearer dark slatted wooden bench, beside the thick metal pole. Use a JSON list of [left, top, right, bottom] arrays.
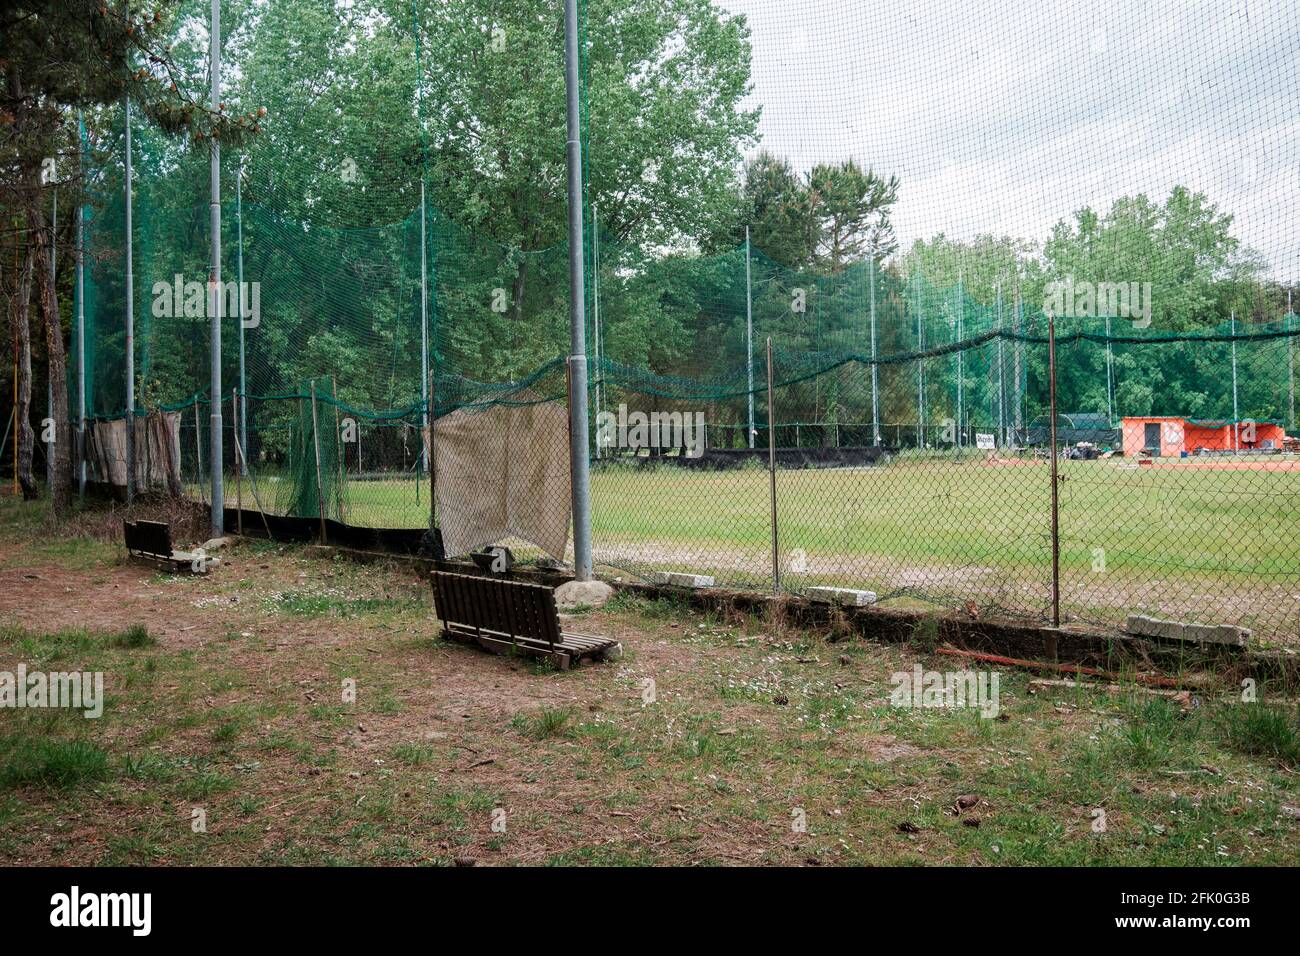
[[432, 571, 623, 670]]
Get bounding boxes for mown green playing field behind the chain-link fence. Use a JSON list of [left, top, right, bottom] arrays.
[[220, 457, 1300, 641]]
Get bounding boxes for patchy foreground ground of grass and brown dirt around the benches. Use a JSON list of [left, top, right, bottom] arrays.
[[0, 501, 1300, 866]]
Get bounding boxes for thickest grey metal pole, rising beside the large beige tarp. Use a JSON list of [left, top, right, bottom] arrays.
[[564, 0, 592, 581]]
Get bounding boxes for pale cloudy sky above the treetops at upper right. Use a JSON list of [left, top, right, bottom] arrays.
[[720, 0, 1300, 280]]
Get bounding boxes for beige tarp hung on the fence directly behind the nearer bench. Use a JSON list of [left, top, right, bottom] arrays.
[[425, 397, 569, 561]]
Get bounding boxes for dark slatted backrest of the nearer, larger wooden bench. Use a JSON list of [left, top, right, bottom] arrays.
[[433, 571, 560, 646]]
